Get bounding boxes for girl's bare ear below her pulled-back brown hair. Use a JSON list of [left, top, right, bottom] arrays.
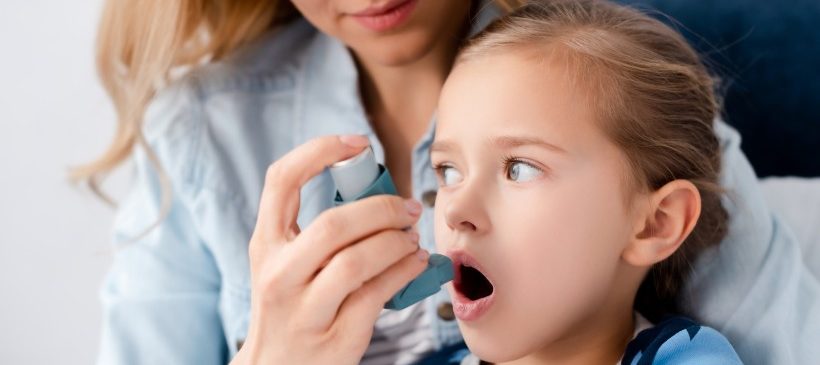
[[621, 180, 701, 267]]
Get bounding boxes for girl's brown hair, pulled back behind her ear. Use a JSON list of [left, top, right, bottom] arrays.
[[457, 0, 727, 320]]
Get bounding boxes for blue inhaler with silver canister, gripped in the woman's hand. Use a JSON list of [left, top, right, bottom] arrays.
[[330, 147, 453, 310]]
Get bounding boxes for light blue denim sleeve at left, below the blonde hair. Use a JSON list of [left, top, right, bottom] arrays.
[[98, 83, 228, 365]]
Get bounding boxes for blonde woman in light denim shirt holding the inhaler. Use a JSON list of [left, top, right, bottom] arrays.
[[75, 0, 812, 364]]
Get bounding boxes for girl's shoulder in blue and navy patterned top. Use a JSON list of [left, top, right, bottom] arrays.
[[621, 316, 742, 365]]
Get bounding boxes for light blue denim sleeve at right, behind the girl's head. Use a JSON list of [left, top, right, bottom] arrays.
[[684, 118, 820, 364]]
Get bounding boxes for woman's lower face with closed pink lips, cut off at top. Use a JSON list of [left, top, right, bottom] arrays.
[[292, 0, 470, 65]]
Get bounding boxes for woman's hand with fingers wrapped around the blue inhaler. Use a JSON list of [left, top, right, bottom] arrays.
[[233, 136, 428, 365]]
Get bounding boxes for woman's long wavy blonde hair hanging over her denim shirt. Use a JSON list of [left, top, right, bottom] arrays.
[[70, 0, 524, 205]]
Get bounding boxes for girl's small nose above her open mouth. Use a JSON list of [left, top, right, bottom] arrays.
[[444, 181, 490, 233]]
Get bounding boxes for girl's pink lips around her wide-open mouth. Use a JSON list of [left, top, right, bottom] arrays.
[[447, 250, 495, 322]]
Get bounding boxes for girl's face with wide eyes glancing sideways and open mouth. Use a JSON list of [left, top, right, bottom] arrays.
[[431, 52, 640, 362]]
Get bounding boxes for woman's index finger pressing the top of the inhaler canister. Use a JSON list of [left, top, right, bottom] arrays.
[[254, 135, 369, 241]]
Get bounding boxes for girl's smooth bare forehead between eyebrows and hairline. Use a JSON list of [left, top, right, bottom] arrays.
[[437, 54, 595, 144]]
